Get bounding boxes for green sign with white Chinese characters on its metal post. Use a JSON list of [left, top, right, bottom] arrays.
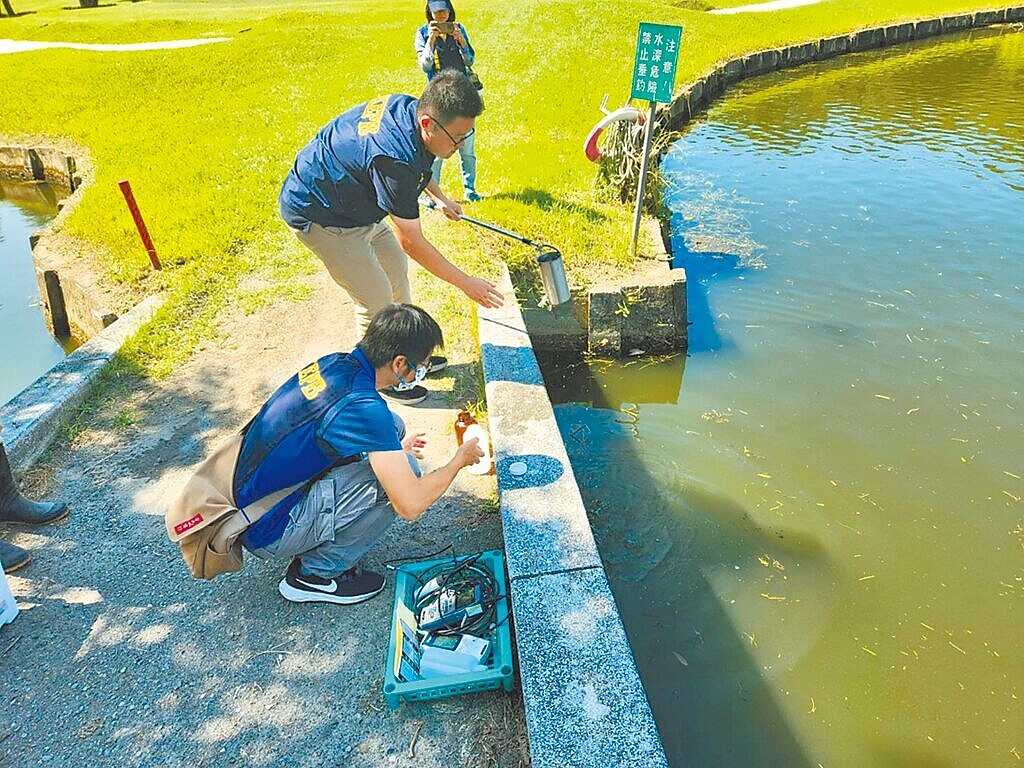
[[630, 23, 683, 254]]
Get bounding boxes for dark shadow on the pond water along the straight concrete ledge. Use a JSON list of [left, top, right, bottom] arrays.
[[544, 355, 824, 768]]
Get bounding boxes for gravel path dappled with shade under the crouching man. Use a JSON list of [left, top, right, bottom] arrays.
[[0, 275, 529, 768]]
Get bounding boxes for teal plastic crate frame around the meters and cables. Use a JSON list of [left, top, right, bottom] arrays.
[[384, 550, 514, 710]]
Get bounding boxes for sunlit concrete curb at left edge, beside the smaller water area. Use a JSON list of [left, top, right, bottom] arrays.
[[0, 296, 165, 470]]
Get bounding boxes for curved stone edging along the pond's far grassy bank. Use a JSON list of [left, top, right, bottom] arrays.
[[658, 5, 1024, 130]]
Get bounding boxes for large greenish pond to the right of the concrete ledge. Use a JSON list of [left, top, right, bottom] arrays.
[[546, 30, 1024, 768]]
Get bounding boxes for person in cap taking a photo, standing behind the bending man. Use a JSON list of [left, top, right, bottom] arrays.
[[416, 0, 483, 201]]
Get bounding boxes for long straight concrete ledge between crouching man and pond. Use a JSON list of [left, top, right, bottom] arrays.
[[478, 269, 668, 768]]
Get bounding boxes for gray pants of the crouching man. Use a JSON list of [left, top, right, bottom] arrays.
[[250, 415, 420, 579]]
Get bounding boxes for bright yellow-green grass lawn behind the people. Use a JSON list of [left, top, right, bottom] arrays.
[[0, 0, 1007, 375]]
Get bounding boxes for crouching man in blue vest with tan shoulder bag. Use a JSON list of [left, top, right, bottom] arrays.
[[166, 304, 483, 604]]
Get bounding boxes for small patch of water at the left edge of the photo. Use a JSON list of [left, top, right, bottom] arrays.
[[0, 181, 66, 404]]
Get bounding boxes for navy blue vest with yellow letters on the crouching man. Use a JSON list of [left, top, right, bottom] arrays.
[[232, 349, 376, 548]]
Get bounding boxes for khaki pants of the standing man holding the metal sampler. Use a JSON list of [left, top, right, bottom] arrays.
[[295, 221, 413, 339]]
